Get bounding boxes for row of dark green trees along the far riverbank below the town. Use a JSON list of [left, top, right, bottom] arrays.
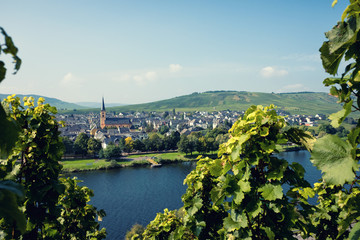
[[62, 125, 228, 159]]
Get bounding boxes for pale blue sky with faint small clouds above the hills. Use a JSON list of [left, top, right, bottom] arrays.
[[0, 0, 348, 104]]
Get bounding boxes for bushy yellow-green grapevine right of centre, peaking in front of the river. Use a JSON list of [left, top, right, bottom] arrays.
[[144, 105, 314, 239]]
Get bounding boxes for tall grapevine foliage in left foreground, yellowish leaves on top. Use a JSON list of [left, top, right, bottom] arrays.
[[0, 95, 106, 239]]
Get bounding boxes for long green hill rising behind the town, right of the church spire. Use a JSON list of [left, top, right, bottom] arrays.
[[107, 91, 341, 114]]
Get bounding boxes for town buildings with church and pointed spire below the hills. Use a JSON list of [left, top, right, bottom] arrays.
[[57, 99, 326, 147]]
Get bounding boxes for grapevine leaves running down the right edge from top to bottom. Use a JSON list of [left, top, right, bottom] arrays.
[[311, 0, 360, 239]]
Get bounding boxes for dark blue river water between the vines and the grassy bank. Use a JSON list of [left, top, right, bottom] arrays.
[[70, 151, 321, 240]]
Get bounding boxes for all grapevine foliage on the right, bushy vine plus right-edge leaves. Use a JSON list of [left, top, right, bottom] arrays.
[[143, 0, 360, 239]]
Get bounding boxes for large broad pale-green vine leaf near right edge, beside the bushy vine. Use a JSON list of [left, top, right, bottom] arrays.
[[311, 135, 358, 185]]
